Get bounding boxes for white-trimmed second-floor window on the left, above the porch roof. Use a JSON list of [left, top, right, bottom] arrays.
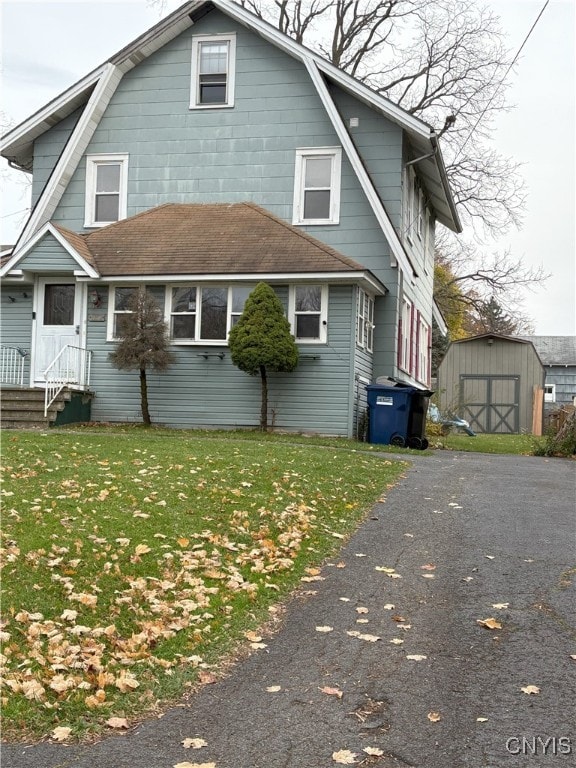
[[84, 154, 128, 227]]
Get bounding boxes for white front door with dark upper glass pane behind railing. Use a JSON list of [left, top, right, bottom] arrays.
[[34, 278, 81, 384]]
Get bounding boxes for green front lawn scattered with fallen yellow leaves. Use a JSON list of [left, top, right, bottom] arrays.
[[1, 429, 406, 741]]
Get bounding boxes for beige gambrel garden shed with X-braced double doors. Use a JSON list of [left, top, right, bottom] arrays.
[[437, 333, 545, 435]]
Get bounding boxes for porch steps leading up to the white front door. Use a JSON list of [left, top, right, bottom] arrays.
[[0, 386, 72, 429]]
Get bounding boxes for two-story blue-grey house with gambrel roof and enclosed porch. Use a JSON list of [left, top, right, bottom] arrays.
[[0, 0, 461, 436]]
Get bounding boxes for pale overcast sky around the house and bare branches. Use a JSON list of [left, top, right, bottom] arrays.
[[0, 0, 576, 335]]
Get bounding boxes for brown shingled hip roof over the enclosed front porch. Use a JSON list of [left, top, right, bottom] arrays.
[[53, 203, 378, 278]]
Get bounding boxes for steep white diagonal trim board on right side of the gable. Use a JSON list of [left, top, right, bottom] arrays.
[[304, 58, 418, 277]]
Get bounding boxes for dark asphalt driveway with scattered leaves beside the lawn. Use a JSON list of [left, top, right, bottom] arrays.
[[2, 452, 576, 768]]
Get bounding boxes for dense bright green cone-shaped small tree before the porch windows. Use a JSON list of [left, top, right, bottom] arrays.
[[228, 283, 298, 431]]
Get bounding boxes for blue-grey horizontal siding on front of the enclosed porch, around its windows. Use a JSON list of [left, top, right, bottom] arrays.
[[87, 286, 354, 436]]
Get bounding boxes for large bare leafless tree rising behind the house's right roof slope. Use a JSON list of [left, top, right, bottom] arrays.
[[237, 0, 525, 234]]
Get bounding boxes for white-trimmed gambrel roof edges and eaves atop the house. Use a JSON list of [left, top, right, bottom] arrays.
[[0, 0, 461, 274]]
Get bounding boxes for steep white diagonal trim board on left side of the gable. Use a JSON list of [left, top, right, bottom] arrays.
[[18, 64, 122, 249]]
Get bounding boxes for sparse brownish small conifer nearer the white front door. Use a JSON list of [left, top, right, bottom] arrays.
[[109, 289, 174, 425]]
